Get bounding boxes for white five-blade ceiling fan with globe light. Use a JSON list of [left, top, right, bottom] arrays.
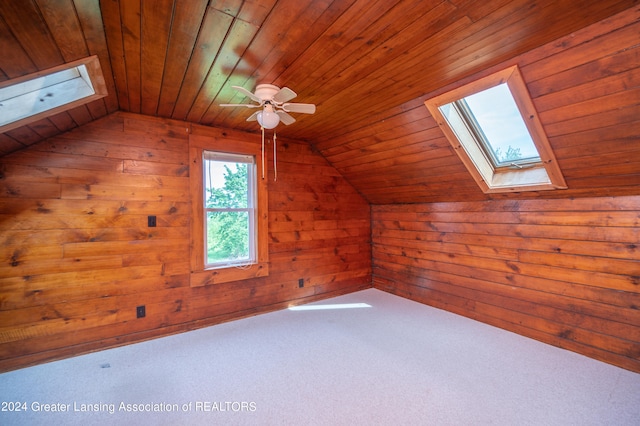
[[220, 84, 316, 129]]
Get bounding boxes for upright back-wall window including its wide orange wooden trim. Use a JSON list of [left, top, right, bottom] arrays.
[[189, 131, 269, 287]]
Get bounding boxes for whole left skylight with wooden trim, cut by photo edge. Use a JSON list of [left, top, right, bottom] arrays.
[[0, 56, 107, 132]]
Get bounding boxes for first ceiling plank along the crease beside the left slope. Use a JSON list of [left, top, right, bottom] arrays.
[[100, 1, 130, 111]]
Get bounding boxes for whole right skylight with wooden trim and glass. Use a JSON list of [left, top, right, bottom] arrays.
[[425, 66, 566, 193]]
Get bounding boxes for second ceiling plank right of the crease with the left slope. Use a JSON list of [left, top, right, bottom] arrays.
[[120, 0, 142, 113]]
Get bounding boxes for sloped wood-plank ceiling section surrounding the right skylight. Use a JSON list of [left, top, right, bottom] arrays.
[[313, 2, 640, 204]]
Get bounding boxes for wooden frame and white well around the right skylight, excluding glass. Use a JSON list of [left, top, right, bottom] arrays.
[[425, 65, 567, 193]]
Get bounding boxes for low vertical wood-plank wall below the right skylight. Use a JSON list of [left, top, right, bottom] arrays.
[[372, 195, 640, 372]]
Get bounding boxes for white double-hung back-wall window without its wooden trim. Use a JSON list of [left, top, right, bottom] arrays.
[[203, 151, 257, 268]]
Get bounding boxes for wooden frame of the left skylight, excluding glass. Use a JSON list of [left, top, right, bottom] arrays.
[[0, 55, 108, 133]]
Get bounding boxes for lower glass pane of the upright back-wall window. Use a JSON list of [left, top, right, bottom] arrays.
[[206, 211, 251, 265]]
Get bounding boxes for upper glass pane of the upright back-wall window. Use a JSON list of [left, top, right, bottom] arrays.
[[205, 160, 251, 209]]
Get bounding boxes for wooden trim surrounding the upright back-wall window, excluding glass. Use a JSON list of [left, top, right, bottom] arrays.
[[189, 134, 269, 287]]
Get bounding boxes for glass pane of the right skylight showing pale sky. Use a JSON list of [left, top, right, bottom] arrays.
[[464, 83, 540, 166]]
